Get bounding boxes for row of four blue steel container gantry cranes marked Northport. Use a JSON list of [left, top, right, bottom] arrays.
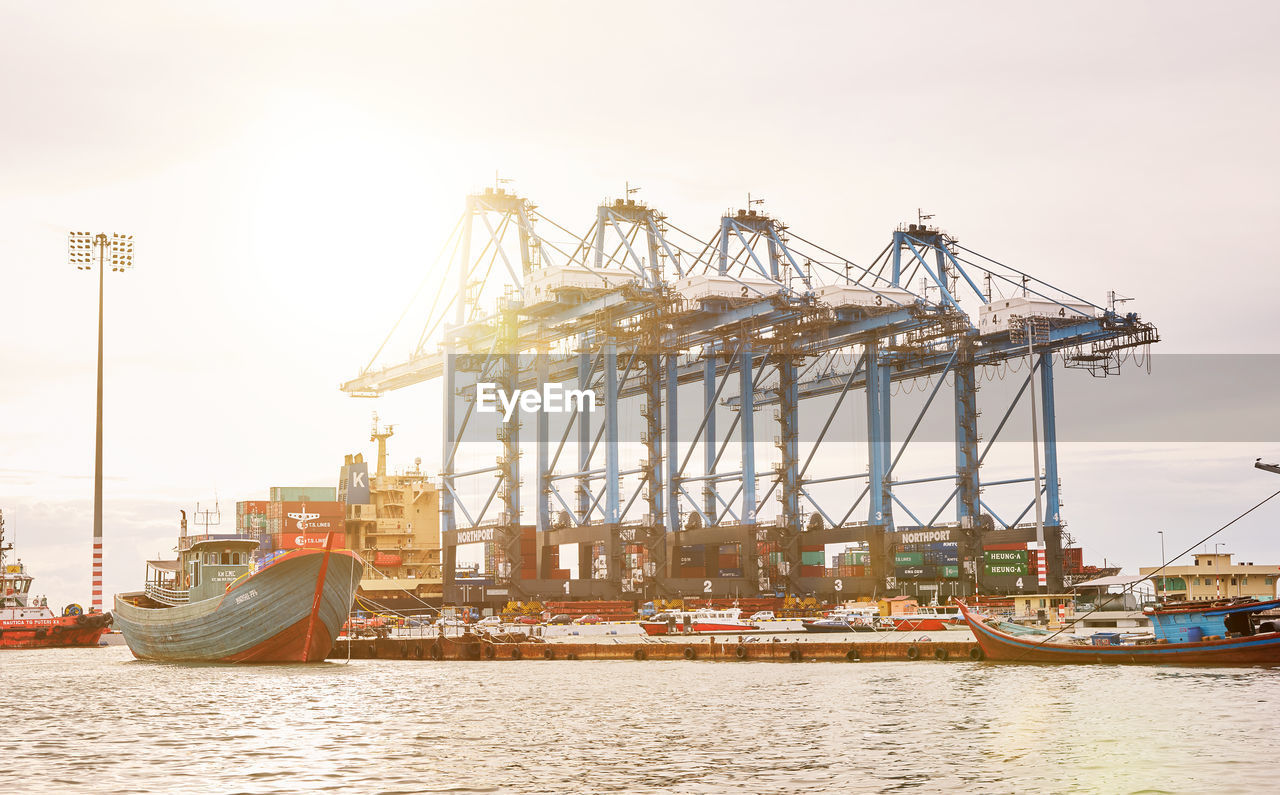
[[342, 188, 1158, 599]]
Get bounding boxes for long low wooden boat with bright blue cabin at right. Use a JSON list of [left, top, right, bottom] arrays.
[[960, 599, 1280, 666]]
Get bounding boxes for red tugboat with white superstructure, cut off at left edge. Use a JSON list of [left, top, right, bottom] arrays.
[[0, 504, 111, 649]]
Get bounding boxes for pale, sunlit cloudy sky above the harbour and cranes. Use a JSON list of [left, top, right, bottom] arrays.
[[0, 3, 1280, 604]]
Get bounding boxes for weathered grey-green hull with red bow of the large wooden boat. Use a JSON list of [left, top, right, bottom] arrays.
[[114, 549, 364, 663]]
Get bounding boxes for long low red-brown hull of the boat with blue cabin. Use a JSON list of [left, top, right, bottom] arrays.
[[960, 606, 1280, 666]]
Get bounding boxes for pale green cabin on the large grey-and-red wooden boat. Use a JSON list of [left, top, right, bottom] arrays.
[[146, 535, 257, 606]]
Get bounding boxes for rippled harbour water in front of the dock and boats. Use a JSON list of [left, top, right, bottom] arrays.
[[0, 646, 1280, 794]]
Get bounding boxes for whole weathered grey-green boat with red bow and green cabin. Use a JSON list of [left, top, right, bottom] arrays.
[[114, 512, 365, 663]]
